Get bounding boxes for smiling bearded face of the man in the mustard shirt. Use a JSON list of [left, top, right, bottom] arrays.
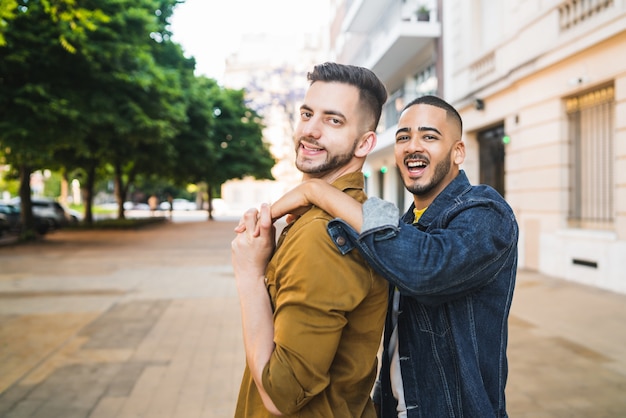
[[295, 81, 376, 183]]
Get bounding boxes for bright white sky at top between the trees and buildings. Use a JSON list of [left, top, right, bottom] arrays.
[[171, 0, 328, 81]]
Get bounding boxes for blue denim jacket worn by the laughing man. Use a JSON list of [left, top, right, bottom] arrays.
[[328, 171, 518, 418]]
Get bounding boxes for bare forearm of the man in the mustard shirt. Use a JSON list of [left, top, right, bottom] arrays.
[[238, 278, 282, 415]]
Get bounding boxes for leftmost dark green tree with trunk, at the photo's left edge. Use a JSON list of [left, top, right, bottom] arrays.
[[0, 0, 106, 236]]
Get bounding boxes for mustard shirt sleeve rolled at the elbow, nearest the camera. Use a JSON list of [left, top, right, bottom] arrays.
[[263, 218, 371, 414]]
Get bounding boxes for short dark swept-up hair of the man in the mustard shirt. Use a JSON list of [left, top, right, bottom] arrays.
[[307, 62, 387, 131]]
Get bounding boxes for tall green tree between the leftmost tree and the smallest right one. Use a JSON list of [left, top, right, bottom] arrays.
[[75, 0, 188, 218]]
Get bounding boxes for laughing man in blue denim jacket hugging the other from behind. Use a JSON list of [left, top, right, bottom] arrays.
[[271, 96, 518, 418]]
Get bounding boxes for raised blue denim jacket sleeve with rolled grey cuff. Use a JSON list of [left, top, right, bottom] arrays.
[[329, 197, 517, 305]]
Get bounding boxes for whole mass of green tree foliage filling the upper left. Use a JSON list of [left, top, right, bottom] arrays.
[[0, 0, 274, 225]]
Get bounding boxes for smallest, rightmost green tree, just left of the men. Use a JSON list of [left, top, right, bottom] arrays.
[[172, 77, 275, 219]]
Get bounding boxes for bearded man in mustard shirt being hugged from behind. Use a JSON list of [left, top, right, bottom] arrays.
[[232, 63, 388, 418]]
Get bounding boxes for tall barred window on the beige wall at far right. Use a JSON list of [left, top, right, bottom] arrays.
[[565, 86, 615, 228]]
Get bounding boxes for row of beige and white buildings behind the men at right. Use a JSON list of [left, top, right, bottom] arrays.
[[331, 0, 626, 293]]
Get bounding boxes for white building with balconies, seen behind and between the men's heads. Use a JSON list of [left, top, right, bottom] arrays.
[[330, 0, 443, 219]]
